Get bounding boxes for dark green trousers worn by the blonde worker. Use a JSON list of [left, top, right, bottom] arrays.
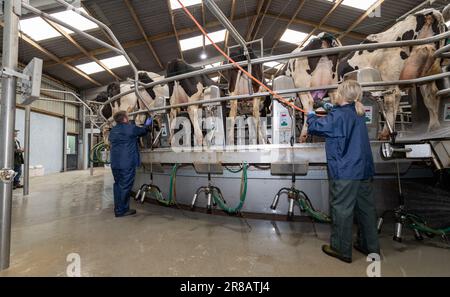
[[330, 180, 380, 258]]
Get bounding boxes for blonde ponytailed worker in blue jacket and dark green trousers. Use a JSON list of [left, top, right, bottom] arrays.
[[308, 80, 380, 263]]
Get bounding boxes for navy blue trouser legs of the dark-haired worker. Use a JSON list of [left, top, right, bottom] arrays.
[[112, 167, 136, 215]]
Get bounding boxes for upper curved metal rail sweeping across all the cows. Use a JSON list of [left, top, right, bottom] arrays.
[[102, 31, 450, 110]]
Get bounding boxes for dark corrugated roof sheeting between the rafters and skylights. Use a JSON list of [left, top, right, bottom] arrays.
[[0, 0, 449, 89]]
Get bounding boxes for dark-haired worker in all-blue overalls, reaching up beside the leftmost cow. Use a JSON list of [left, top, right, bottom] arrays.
[[109, 111, 152, 217]]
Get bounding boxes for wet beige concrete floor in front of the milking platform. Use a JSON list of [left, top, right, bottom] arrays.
[[0, 169, 450, 276]]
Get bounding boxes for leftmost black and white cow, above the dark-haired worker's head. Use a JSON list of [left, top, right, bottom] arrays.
[[95, 72, 167, 144]]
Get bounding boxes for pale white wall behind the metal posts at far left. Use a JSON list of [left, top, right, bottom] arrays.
[[16, 109, 64, 174]]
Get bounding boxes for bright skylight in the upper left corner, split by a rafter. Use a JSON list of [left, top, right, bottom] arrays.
[[19, 9, 98, 41]]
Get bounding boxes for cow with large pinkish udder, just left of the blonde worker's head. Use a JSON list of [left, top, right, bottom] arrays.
[[285, 33, 342, 142]]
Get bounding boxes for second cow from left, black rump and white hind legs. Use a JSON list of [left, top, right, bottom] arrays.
[[167, 59, 217, 146]]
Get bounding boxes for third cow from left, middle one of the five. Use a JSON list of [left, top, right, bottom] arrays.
[[227, 48, 266, 145]]
